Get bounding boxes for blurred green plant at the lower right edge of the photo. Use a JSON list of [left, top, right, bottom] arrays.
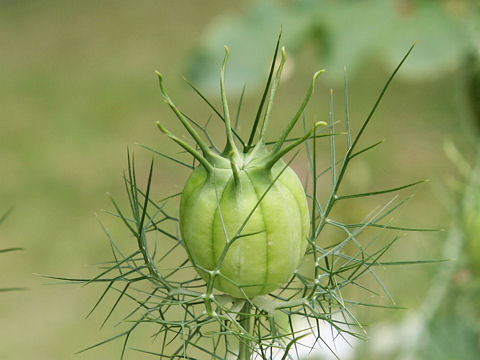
[[424, 142, 480, 360]]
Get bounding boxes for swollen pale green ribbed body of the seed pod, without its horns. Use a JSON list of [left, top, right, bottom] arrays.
[[180, 162, 309, 298]]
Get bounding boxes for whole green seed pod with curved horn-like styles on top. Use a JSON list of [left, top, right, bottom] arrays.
[[157, 44, 325, 298]]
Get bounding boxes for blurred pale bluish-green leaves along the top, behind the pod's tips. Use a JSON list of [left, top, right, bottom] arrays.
[[188, 0, 480, 91]]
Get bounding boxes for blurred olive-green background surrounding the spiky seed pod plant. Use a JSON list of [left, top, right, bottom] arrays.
[[0, 0, 479, 360]]
